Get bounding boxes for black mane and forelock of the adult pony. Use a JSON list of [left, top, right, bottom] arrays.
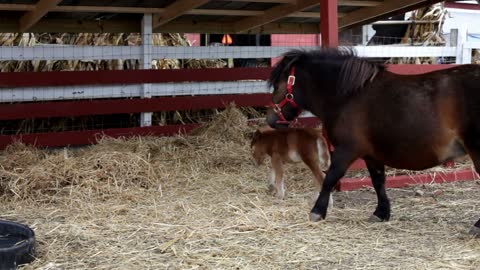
[[268, 48, 385, 95]]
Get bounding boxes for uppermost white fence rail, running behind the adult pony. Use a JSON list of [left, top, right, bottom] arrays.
[[0, 45, 457, 61]]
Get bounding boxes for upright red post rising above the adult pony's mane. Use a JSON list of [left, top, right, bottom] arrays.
[[320, 0, 338, 47]]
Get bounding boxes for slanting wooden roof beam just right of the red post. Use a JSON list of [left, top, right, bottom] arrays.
[[338, 0, 442, 30]]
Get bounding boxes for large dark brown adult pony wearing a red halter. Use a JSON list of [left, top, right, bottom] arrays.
[[267, 49, 480, 235]]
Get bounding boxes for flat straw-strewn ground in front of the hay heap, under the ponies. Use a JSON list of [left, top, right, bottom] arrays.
[[0, 175, 480, 270]]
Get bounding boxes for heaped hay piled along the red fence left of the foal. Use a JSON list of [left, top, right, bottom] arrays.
[[0, 105, 254, 199]]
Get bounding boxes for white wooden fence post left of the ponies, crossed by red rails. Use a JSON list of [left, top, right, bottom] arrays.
[[140, 14, 153, 127]]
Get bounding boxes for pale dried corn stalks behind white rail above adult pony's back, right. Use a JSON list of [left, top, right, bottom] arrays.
[[387, 3, 447, 64]]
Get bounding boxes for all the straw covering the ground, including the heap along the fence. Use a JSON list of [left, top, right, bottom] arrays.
[[0, 107, 480, 270]]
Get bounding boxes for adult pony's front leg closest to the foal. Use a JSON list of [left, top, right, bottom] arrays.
[[310, 147, 357, 221]]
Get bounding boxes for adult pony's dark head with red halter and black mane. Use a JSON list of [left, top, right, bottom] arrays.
[[267, 48, 383, 128]]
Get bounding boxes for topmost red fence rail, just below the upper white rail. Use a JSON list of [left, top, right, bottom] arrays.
[[0, 65, 455, 88]]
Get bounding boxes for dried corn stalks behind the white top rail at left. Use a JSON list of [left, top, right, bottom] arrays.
[[0, 33, 226, 72]]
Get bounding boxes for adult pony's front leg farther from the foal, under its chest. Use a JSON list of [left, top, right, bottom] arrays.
[[365, 158, 390, 222]]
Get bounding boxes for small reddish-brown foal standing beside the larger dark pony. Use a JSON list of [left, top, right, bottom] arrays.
[[251, 128, 332, 205]]
